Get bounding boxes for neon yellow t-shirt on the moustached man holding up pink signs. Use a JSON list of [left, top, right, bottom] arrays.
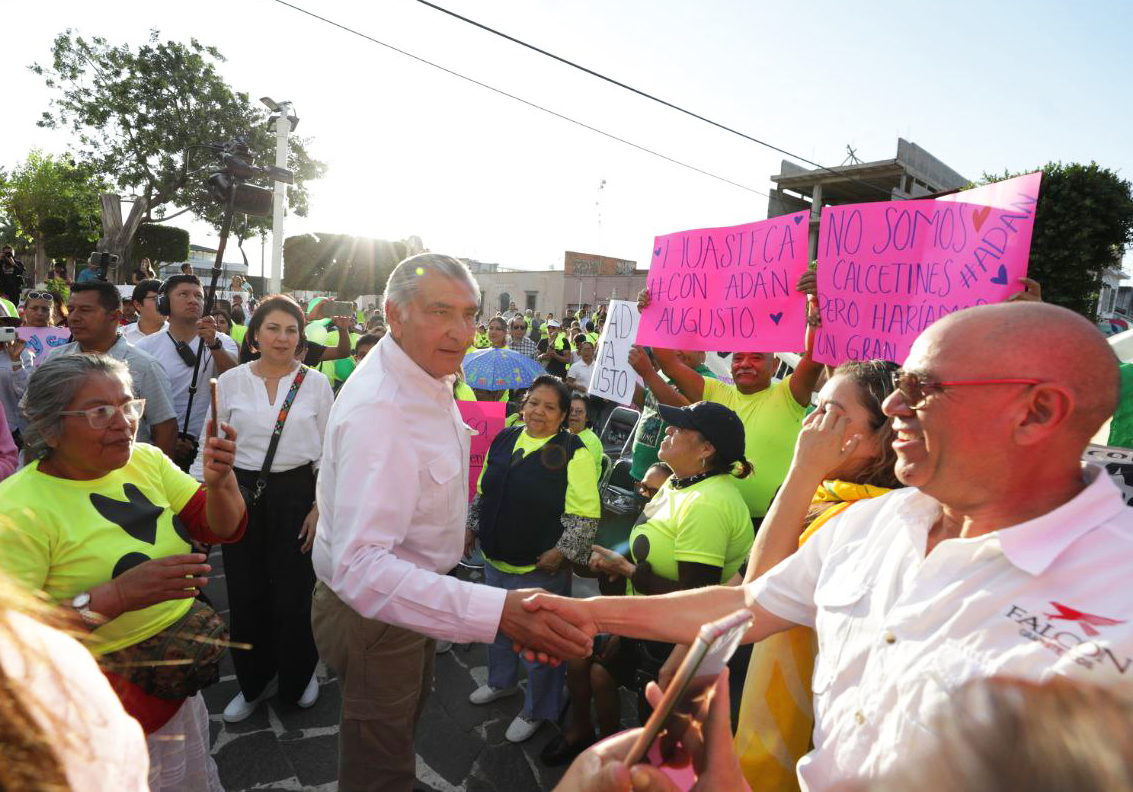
[[705, 377, 806, 517]]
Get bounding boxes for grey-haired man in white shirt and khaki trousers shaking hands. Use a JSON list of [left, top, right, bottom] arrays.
[[312, 254, 590, 792]]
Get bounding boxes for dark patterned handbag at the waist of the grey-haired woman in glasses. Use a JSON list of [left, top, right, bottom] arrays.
[[100, 599, 229, 700]]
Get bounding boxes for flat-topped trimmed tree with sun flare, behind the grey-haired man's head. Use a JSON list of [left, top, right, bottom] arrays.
[[283, 233, 425, 299]]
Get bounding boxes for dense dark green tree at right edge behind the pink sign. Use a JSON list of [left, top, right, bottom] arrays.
[[980, 162, 1133, 321]]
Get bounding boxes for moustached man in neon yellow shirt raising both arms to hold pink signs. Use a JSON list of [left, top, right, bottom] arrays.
[[638, 277, 823, 520]]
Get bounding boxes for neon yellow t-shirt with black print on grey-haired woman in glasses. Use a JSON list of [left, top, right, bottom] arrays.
[[0, 443, 199, 654]]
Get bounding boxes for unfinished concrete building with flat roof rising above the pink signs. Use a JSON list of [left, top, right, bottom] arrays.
[[767, 137, 969, 259]]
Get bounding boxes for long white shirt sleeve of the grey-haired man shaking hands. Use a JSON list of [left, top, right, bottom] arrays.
[[320, 404, 508, 644]]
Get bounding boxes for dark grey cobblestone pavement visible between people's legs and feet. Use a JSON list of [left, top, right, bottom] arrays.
[[204, 548, 636, 792]]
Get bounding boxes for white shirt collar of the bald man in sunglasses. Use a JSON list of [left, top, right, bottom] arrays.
[[894, 465, 1126, 576]]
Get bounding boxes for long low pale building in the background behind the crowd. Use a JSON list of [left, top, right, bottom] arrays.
[[461, 250, 648, 317]]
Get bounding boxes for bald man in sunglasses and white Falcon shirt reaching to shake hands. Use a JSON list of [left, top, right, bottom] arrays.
[[518, 303, 1133, 790]]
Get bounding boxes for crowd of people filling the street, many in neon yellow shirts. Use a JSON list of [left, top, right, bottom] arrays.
[[0, 252, 1133, 792]]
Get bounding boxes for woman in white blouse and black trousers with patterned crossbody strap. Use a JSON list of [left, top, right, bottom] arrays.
[[193, 295, 334, 723]]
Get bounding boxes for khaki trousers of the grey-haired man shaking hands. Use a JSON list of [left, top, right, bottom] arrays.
[[310, 581, 436, 792]]
